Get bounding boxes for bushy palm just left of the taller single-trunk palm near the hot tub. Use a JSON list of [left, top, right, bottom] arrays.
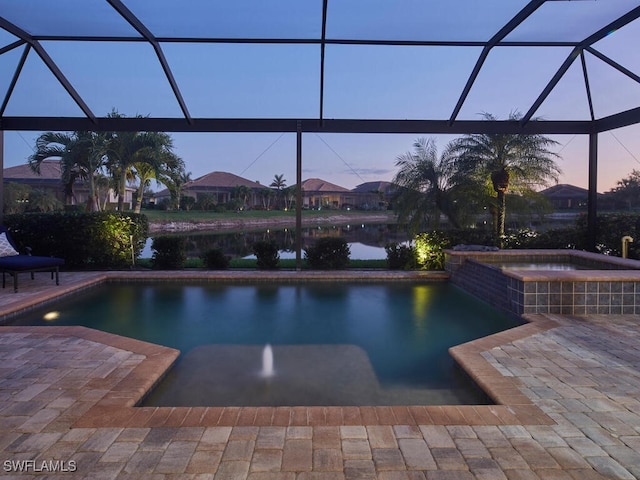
[[393, 138, 458, 232]]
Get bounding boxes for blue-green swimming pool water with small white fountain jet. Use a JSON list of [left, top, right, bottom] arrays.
[[7, 282, 522, 406]]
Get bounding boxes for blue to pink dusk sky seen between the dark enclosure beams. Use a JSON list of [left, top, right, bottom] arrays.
[[0, 0, 640, 191]]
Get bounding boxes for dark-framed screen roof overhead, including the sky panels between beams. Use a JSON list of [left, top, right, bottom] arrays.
[[0, 0, 640, 134]]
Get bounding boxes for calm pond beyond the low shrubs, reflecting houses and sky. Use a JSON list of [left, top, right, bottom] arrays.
[[141, 224, 409, 260]]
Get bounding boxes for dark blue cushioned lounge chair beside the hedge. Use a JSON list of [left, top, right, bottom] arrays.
[[0, 225, 64, 292]]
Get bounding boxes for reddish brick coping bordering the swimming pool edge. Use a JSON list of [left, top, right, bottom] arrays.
[[0, 271, 558, 428]]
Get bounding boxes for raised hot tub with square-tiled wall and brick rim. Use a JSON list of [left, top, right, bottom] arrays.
[[445, 250, 640, 315]]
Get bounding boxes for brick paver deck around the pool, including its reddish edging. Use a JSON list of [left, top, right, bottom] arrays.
[[0, 272, 640, 480]]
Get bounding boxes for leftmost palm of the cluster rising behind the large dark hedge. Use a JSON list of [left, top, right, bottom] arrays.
[[28, 131, 106, 211]]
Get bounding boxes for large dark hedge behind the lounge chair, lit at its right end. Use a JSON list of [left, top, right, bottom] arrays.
[[4, 211, 149, 269]]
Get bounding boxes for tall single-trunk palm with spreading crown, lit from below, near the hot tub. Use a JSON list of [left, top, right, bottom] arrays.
[[448, 113, 561, 246]]
